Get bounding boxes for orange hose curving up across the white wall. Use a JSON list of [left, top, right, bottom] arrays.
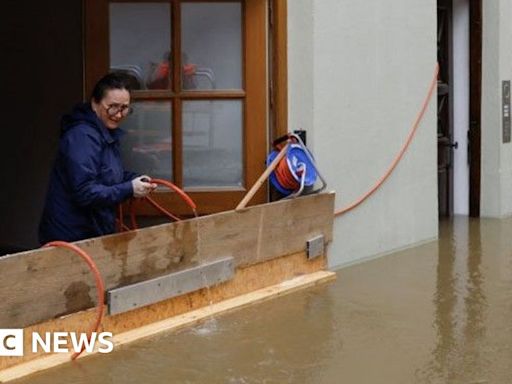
[[334, 64, 439, 217]]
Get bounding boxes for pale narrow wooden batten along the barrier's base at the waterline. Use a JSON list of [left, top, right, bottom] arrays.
[[0, 271, 336, 383]]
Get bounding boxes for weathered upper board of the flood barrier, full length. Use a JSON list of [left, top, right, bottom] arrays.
[[0, 194, 334, 328]]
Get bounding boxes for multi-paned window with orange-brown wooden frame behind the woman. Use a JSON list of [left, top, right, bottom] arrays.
[[85, 0, 268, 213]]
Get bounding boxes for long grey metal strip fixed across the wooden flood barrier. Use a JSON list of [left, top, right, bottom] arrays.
[[107, 257, 235, 315]]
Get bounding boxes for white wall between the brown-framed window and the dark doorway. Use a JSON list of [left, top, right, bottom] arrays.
[[288, 0, 438, 267]]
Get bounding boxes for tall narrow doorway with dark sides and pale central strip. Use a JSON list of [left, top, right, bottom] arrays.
[[437, 0, 482, 218]]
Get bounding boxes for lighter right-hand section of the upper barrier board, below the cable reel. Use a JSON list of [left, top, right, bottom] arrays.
[[202, 195, 334, 266]]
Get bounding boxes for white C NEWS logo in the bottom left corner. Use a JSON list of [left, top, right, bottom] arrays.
[[0, 329, 114, 356]]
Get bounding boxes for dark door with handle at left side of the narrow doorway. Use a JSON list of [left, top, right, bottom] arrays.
[[437, 0, 457, 217]]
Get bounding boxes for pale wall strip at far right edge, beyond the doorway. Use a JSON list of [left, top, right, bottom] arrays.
[[481, 0, 512, 217]]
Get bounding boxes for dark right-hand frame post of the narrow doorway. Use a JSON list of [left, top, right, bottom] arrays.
[[468, 0, 482, 217]]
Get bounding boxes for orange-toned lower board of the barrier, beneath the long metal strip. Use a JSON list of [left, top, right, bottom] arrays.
[[0, 252, 326, 370]]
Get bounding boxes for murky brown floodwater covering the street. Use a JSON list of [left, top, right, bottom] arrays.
[[11, 217, 512, 384]]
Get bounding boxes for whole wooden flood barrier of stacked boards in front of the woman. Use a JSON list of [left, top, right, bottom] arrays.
[[0, 193, 334, 381]]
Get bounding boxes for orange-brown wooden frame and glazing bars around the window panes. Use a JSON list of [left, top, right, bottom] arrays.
[[84, 0, 273, 215]]
